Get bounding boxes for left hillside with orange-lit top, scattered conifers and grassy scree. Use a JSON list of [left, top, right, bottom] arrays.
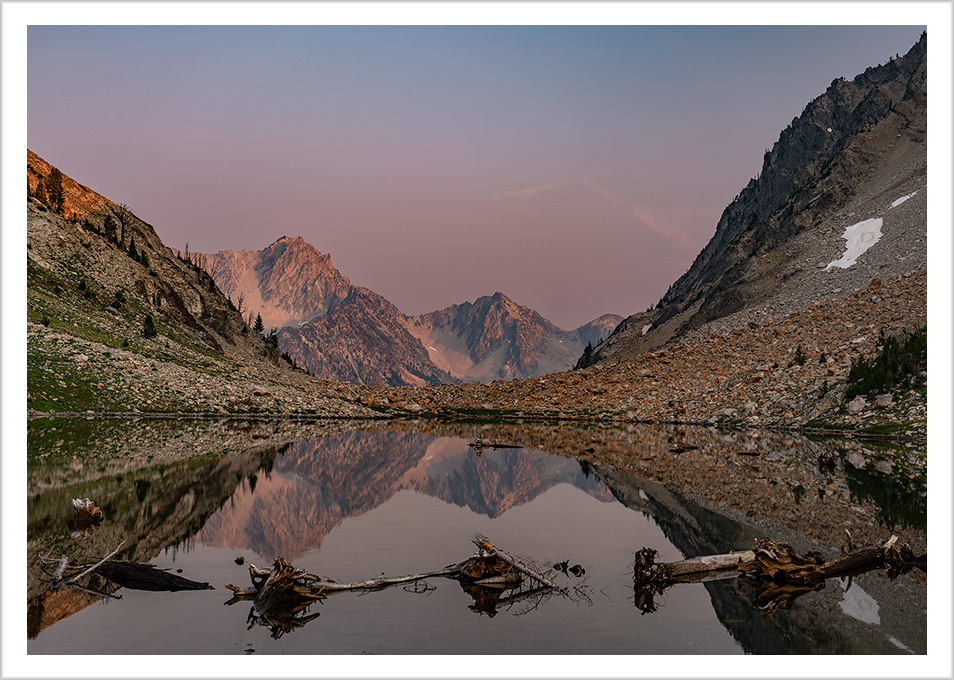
[[27, 151, 373, 415]]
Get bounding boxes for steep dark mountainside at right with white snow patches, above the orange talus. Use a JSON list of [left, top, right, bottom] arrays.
[[585, 34, 927, 365]]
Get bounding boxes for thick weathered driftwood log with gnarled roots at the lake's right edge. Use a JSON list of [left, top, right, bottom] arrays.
[[633, 534, 927, 613]]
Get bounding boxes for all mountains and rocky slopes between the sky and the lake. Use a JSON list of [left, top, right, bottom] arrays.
[[27, 35, 927, 437]]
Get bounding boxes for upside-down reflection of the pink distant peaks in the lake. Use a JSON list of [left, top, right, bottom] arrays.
[[197, 432, 613, 560]]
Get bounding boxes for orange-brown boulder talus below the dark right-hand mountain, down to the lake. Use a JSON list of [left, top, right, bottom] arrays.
[[357, 269, 927, 436]]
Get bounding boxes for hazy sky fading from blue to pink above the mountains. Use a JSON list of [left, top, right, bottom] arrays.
[[28, 23, 923, 328]]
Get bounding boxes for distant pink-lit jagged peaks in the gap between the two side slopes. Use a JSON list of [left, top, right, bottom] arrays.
[[197, 236, 622, 385]]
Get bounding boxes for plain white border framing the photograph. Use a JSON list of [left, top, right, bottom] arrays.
[[0, 2, 954, 678]]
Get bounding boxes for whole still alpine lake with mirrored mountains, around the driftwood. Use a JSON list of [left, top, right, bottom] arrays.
[[26, 418, 927, 655]]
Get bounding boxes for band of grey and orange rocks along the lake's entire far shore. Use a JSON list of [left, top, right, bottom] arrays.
[[28, 269, 927, 438]]
